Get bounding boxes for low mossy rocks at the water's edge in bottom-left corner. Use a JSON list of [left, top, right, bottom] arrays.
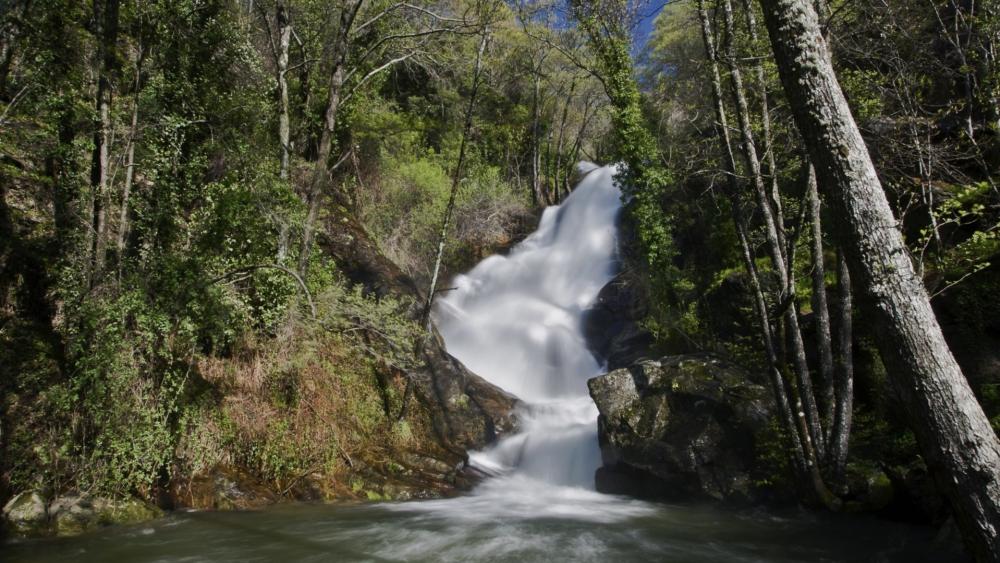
[[3, 491, 163, 536]]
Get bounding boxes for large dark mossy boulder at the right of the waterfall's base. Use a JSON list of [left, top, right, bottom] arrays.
[[588, 355, 773, 502]]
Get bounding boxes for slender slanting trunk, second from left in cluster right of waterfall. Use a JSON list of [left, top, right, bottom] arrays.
[[722, 0, 825, 454]]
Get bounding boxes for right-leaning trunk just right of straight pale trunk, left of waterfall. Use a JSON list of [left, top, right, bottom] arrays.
[[299, 0, 364, 278]]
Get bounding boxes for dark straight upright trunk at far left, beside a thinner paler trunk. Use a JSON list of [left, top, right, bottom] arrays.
[[90, 0, 119, 286]]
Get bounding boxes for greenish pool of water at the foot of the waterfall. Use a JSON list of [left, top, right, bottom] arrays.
[[0, 476, 964, 563]]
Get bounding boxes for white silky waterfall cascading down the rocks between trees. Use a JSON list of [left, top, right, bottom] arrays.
[[434, 164, 621, 489]]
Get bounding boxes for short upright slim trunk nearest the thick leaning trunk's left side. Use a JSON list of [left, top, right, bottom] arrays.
[[829, 251, 854, 485]]
